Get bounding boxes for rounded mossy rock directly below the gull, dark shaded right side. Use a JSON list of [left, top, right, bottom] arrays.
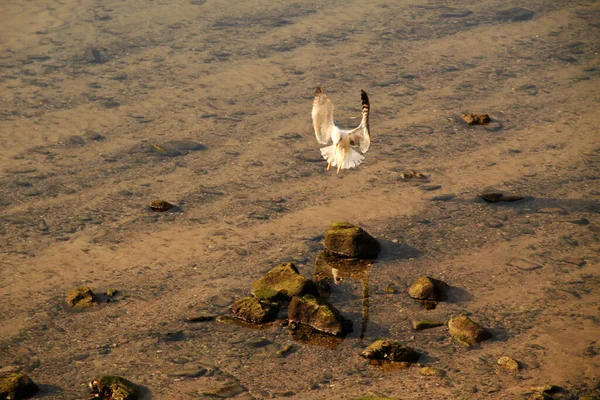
[[324, 222, 381, 259]]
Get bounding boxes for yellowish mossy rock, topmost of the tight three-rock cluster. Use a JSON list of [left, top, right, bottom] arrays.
[[251, 263, 319, 302]]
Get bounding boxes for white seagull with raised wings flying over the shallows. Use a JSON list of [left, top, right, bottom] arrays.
[[312, 87, 371, 174]]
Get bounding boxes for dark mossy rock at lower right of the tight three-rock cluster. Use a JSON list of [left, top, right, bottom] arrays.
[[288, 294, 352, 336]]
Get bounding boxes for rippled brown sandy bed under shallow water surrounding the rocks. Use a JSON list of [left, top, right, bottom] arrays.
[[0, 0, 600, 399]]
